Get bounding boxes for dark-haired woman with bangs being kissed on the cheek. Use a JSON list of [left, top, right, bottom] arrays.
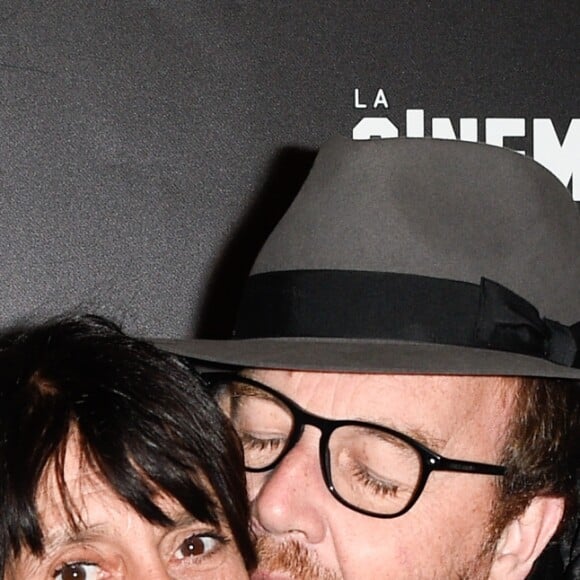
[[0, 316, 255, 580]]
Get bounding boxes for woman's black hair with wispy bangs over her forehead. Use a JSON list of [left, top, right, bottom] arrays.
[[0, 316, 256, 578]]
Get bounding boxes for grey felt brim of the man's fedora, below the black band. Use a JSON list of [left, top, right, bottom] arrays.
[[151, 338, 580, 379]]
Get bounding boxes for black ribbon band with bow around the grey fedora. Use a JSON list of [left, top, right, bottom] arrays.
[[234, 270, 580, 367]]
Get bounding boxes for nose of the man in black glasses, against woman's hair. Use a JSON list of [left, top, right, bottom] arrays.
[[248, 429, 334, 544]]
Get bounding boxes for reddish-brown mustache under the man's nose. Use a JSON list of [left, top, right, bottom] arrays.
[[256, 536, 342, 580]]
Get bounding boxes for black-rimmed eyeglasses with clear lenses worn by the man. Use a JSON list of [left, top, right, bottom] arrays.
[[204, 373, 506, 518]]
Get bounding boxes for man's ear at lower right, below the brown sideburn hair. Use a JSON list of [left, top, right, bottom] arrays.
[[490, 496, 564, 580]]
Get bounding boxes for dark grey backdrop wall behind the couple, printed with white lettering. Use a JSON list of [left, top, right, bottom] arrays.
[[0, 0, 580, 336]]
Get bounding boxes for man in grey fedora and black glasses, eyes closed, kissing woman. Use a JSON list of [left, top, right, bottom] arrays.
[[159, 138, 580, 580]]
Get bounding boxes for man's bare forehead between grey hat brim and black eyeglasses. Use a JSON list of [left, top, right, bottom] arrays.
[[244, 369, 521, 438]]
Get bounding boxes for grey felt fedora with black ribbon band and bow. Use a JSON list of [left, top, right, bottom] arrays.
[[155, 137, 580, 379]]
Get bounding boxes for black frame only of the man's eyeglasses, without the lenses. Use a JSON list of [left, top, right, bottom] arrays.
[[201, 371, 507, 519]]
